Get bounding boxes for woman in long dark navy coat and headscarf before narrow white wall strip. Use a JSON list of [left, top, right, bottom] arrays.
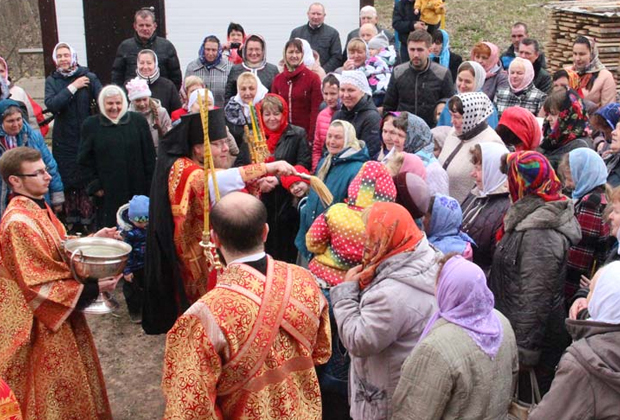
[[45, 42, 101, 232]]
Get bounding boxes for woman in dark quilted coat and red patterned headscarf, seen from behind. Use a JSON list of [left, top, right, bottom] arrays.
[[489, 151, 581, 401]]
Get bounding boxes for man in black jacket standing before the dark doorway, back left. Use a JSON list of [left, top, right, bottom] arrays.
[[112, 9, 183, 89]]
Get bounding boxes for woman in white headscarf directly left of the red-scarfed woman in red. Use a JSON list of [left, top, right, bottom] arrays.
[[224, 71, 269, 165]]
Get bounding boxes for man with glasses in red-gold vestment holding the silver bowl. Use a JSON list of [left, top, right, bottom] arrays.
[[0, 147, 120, 420]]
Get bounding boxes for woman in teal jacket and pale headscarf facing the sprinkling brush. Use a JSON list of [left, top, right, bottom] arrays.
[[295, 120, 370, 261]]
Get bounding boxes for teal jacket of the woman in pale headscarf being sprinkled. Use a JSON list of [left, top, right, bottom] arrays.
[[295, 142, 370, 260]]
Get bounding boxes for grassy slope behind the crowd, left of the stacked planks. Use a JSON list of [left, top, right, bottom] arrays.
[[375, 0, 549, 57]]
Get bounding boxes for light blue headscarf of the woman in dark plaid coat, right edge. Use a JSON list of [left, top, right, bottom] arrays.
[[568, 147, 607, 200]]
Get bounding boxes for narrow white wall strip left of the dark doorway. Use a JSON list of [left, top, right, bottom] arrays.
[[55, 0, 88, 66]]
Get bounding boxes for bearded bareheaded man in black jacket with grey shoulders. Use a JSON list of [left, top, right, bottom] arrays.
[[383, 29, 455, 128]]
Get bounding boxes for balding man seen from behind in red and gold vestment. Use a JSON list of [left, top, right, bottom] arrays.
[[162, 193, 331, 420]]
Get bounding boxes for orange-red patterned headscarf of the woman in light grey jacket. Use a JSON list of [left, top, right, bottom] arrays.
[[359, 202, 424, 290]]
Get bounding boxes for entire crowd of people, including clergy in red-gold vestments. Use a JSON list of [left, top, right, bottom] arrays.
[[0, 0, 620, 420]]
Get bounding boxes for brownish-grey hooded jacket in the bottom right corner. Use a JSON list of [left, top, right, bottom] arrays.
[[529, 319, 620, 420]]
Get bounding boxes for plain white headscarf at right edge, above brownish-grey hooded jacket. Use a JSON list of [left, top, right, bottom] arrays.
[[588, 261, 620, 325]]
